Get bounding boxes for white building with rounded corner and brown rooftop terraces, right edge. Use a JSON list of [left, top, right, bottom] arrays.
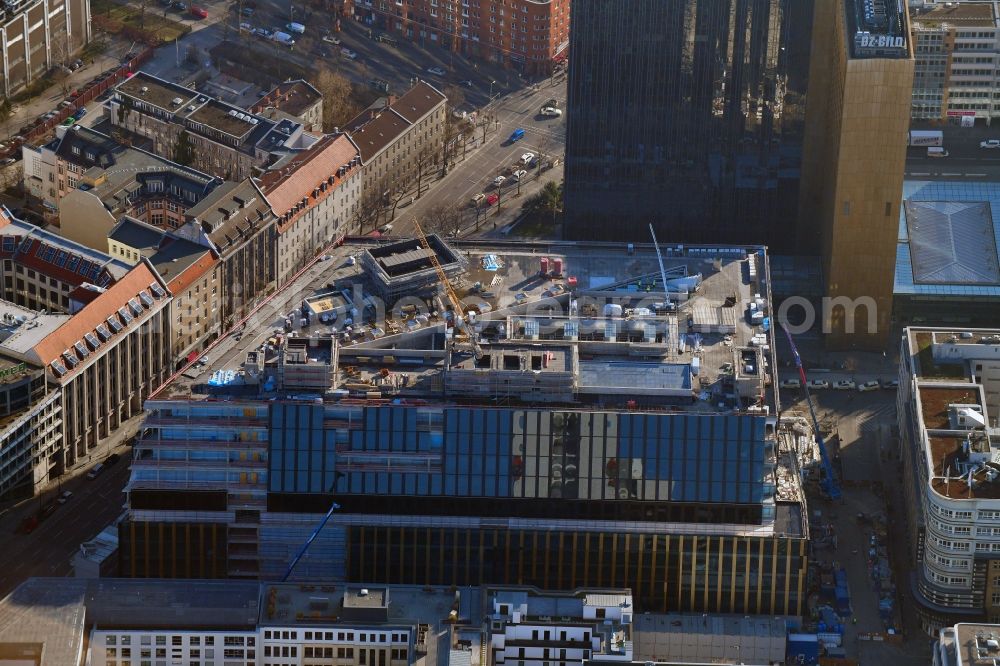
[[897, 328, 1000, 635]]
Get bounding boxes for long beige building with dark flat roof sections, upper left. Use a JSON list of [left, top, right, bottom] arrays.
[[111, 72, 317, 181]]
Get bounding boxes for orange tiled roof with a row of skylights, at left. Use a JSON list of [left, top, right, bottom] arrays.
[[34, 261, 164, 379]]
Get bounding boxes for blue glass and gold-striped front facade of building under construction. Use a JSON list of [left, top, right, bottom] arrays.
[[121, 400, 806, 613]]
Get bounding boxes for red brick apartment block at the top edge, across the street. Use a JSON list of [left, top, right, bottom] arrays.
[[354, 0, 570, 75]]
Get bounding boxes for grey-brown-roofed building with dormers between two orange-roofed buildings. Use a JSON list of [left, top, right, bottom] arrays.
[[180, 179, 278, 330]]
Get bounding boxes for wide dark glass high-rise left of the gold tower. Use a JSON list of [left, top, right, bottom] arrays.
[[565, 0, 812, 249]]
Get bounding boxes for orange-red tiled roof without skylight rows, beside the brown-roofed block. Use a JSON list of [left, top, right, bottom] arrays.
[[260, 134, 358, 232]]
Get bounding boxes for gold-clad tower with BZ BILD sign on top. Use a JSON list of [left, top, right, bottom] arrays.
[[799, 0, 913, 351]]
